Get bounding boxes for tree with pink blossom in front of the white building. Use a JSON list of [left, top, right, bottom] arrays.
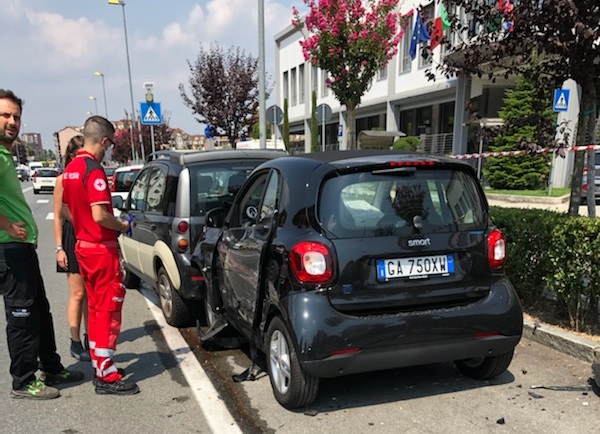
[[292, 0, 406, 149]]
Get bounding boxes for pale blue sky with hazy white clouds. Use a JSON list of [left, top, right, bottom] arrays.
[[0, 0, 306, 149]]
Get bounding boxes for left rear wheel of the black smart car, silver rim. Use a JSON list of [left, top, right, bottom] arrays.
[[267, 317, 319, 409]]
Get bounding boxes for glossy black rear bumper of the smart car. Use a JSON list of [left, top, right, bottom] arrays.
[[286, 278, 523, 378]]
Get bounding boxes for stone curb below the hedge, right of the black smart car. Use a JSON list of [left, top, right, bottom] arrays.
[[523, 316, 600, 363]]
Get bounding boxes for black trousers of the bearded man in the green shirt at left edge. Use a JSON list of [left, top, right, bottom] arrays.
[[0, 243, 64, 389]]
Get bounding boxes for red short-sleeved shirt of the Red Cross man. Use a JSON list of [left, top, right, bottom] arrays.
[[63, 150, 116, 243]]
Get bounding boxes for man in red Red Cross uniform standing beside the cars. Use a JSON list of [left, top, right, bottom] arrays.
[[63, 116, 139, 395]]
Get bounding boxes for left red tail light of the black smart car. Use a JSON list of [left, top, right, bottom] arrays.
[[290, 241, 333, 284]]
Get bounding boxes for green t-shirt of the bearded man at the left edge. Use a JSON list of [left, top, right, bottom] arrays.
[[0, 145, 38, 245]]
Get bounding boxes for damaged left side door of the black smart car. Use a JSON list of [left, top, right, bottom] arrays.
[[217, 171, 280, 335]]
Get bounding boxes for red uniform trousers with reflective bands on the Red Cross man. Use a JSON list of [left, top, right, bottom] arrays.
[[75, 241, 125, 382]]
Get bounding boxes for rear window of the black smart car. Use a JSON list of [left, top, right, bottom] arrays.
[[317, 169, 485, 238]]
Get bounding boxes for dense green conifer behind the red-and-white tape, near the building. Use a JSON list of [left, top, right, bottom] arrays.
[[483, 75, 556, 190]]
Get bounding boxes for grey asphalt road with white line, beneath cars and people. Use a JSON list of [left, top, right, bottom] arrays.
[[0, 185, 600, 434]]
